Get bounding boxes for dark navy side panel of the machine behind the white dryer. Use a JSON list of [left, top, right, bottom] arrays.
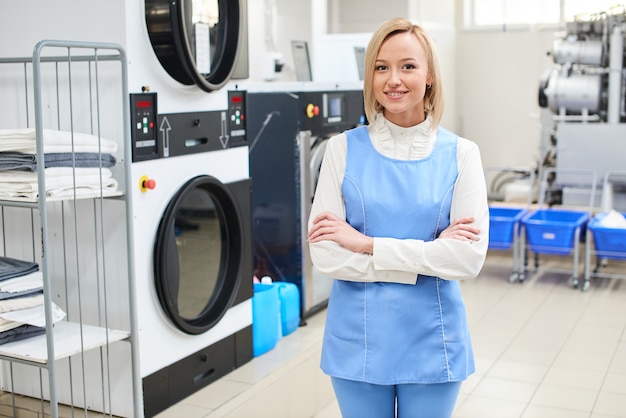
[[247, 93, 302, 284]]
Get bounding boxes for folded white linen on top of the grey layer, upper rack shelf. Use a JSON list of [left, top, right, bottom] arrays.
[[0, 128, 117, 154]]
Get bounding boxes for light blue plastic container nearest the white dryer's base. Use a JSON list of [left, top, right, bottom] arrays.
[[252, 283, 280, 357]]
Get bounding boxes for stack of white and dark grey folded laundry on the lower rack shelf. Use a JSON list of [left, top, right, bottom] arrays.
[[0, 257, 65, 344]]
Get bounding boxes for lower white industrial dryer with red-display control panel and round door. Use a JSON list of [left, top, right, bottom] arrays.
[[131, 92, 253, 416]]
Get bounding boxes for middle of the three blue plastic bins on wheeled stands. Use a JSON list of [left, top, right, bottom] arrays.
[[522, 209, 589, 255]]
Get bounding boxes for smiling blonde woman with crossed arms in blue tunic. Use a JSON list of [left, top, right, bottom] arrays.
[[309, 18, 489, 418]]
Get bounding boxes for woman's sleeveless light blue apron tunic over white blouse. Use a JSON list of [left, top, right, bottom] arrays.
[[321, 126, 475, 385]]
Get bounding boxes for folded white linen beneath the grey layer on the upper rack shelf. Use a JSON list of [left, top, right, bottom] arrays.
[[0, 167, 118, 198]]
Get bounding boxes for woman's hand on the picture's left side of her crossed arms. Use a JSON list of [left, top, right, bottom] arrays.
[[309, 212, 374, 254]]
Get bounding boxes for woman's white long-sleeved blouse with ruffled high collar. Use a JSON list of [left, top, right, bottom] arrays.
[[309, 114, 489, 284]]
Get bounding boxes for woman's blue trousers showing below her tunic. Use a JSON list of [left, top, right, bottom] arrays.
[[331, 377, 462, 418]]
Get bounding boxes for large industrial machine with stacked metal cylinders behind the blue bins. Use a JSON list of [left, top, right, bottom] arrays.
[[538, 8, 626, 210]]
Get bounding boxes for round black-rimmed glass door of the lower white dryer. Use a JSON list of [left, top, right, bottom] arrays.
[[154, 176, 243, 334]]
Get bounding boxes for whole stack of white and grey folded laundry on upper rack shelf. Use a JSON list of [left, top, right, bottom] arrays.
[[0, 129, 118, 199]]
